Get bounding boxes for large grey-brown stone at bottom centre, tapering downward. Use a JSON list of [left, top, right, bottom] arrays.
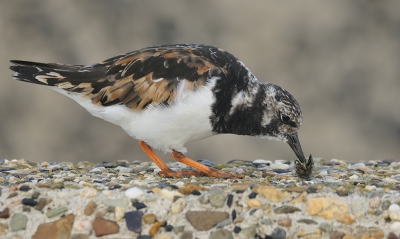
[[186, 211, 229, 231]]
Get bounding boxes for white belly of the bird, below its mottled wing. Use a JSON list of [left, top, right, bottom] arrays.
[[52, 84, 214, 153]]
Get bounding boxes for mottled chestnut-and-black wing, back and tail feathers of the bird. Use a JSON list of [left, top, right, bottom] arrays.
[[11, 45, 231, 110]]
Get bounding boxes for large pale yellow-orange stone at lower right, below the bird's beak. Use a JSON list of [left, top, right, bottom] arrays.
[[306, 197, 349, 219]]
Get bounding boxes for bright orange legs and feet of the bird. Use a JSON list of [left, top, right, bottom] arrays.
[[139, 140, 244, 178]]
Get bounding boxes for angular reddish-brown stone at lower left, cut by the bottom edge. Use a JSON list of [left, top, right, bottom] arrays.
[[32, 214, 75, 239]]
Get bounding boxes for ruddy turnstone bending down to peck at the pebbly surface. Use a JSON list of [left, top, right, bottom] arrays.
[[10, 44, 313, 178]]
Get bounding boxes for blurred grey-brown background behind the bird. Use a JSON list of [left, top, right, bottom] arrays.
[[0, 0, 400, 163]]
